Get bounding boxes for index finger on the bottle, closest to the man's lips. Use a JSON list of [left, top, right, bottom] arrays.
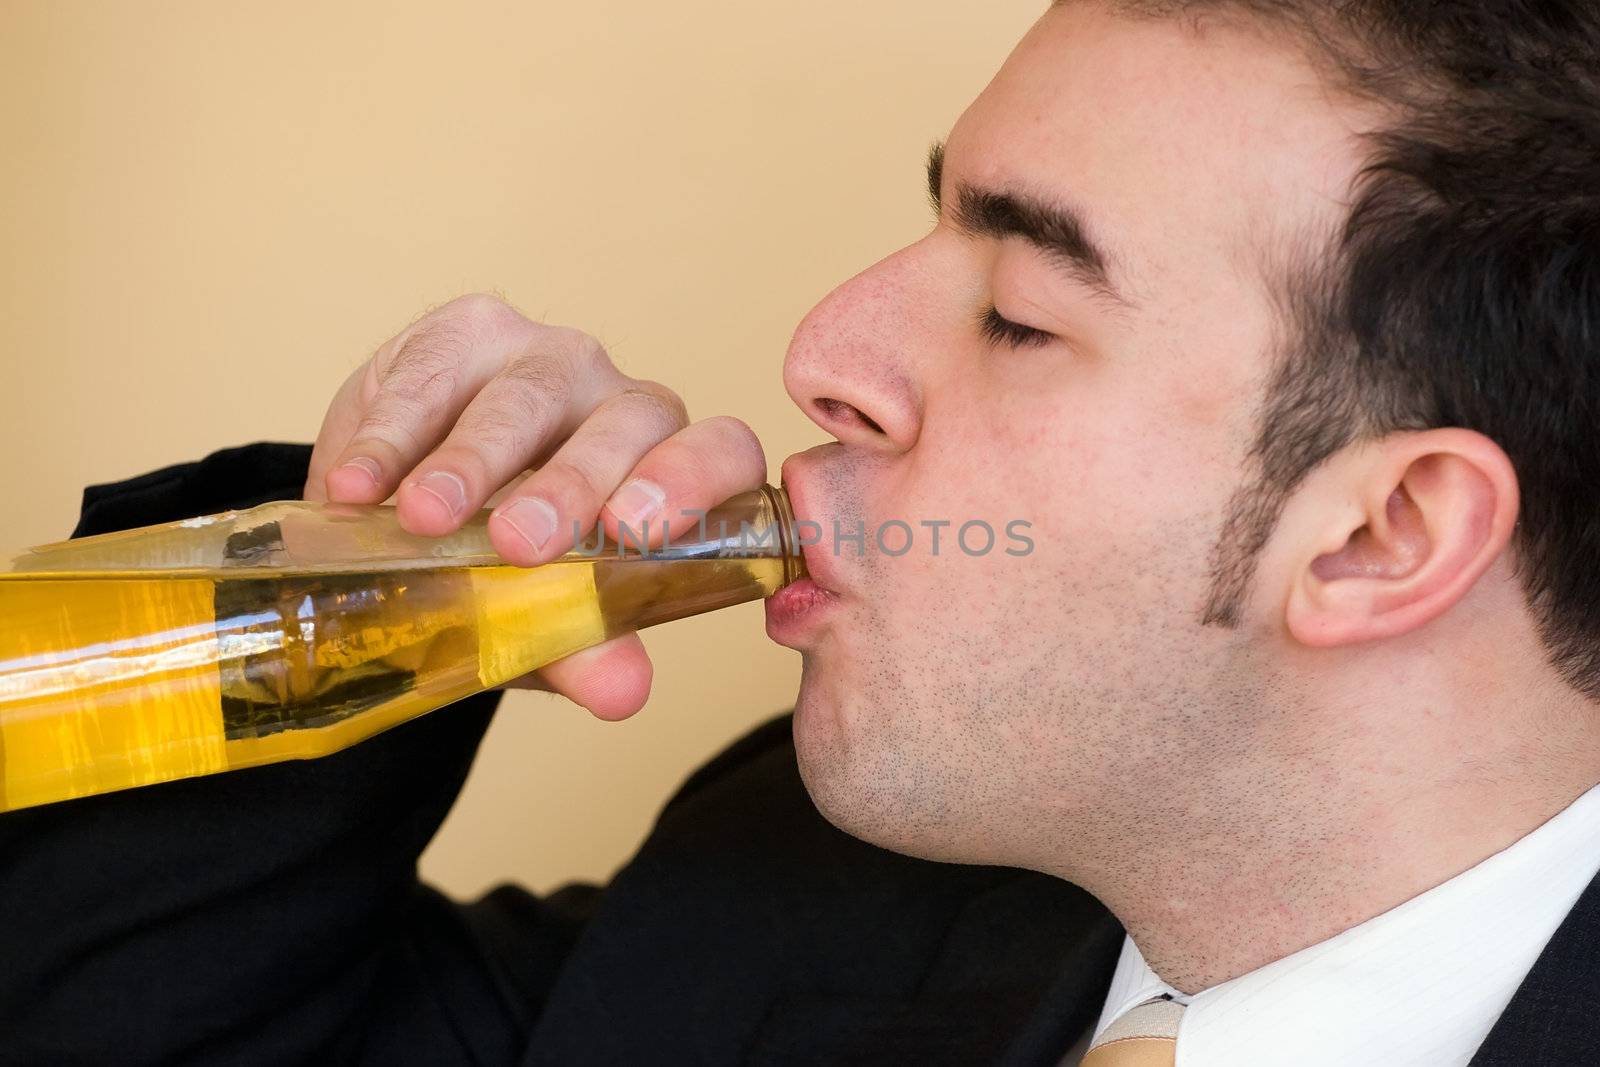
[[600, 416, 766, 545]]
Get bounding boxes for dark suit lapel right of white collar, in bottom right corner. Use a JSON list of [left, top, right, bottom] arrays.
[[1467, 877, 1600, 1067]]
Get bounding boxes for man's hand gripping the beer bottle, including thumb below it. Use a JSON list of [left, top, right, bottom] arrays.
[[306, 296, 766, 718]]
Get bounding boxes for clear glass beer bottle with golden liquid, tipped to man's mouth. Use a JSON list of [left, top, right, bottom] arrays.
[[0, 486, 805, 811]]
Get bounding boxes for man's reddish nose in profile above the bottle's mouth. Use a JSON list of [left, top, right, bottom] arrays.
[[784, 246, 928, 453]]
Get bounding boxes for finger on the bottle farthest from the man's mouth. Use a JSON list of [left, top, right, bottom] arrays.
[[326, 294, 538, 504]]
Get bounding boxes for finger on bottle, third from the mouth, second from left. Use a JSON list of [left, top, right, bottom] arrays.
[[395, 326, 630, 536]]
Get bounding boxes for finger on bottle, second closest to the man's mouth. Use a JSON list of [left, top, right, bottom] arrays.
[[488, 382, 688, 566]]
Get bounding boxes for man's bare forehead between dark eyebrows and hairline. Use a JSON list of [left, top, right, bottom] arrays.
[[949, 2, 1370, 299]]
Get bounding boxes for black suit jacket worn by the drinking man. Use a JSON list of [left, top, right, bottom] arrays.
[[0, 445, 1600, 1067]]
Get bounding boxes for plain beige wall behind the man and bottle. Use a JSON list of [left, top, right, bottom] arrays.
[[0, 0, 1045, 894]]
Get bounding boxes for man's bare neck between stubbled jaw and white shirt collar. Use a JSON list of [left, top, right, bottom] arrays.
[[1056, 646, 1600, 993]]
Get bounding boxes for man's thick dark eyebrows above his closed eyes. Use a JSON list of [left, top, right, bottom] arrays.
[[928, 141, 1128, 304]]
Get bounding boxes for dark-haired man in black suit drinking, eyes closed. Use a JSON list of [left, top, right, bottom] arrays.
[[0, 0, 1600, 1067]]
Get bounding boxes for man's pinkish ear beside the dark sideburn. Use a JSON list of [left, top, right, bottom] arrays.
[[1286, 429, 1518, 648]]
